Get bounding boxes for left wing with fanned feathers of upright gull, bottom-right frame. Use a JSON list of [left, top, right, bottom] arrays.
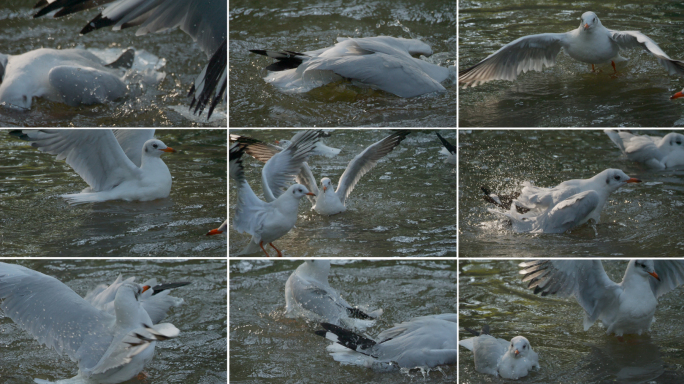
[[520, 260, 622, 329]]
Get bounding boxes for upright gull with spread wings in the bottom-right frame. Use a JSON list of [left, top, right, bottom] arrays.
[[520, 260, 684, 336]]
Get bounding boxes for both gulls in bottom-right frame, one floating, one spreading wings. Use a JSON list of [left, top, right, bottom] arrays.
[[459, 260, 684, 379]]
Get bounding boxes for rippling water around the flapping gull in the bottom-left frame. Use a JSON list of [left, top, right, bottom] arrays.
[[0, 259, 228, 384]]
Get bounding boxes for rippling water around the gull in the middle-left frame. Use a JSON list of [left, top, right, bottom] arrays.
[[0, 129, 227, 257]]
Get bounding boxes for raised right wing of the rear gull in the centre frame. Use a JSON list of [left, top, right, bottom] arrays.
[[335, 130, 411, 204]]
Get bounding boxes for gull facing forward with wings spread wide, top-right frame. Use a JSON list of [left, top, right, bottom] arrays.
[[458, 12, 684, 88]]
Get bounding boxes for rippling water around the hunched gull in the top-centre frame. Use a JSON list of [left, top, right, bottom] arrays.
[[229, 0, 456, 127]]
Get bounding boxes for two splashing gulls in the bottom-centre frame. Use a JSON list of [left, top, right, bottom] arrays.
[[285, 260, 457, 370]]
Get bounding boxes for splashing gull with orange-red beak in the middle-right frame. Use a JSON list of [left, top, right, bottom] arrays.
[[488, 169, 641, 233]]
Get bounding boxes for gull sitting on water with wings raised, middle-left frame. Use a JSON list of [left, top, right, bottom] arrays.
[[10, 129, 176, 204]]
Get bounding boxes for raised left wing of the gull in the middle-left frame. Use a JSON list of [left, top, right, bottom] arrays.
[[10, 129, 142, 192]]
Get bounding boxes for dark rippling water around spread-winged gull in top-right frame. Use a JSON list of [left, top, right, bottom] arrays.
[[459, 0, 684, 127]]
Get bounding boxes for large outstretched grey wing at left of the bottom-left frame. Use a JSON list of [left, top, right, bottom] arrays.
[[0, 263, 115, 370]]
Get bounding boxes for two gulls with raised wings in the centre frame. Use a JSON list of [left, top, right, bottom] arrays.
[[229, 130, 409, 256]]
